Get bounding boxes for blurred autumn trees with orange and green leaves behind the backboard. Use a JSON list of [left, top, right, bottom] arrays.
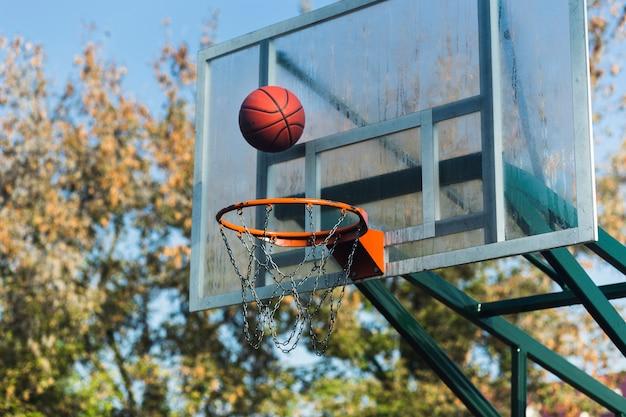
[[0, 1, 626, 416]]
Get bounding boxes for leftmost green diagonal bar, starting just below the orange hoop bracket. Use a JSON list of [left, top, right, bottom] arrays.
[[356, 281, 500, 417]]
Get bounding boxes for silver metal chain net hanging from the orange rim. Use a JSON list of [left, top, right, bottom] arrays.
[[220, 204, 361, 355]]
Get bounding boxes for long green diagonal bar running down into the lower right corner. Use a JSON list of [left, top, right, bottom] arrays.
[[403, 272, 626, 413]]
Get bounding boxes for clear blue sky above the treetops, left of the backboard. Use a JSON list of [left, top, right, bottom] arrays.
[[0, 0, 333, 101]]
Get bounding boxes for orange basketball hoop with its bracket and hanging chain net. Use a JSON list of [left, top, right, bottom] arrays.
[[215, 198, 384, 354]]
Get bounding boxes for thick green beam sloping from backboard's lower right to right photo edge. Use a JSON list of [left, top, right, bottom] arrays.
[[543, 248, 626, 356]]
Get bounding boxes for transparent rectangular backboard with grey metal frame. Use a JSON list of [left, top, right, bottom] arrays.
[[190, 0, 597, 310]]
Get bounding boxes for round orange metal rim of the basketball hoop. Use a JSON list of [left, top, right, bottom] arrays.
[[215, 197, 367, 247]]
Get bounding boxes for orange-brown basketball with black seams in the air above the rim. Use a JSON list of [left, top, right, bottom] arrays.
[[239, 86, 304, 152]]
